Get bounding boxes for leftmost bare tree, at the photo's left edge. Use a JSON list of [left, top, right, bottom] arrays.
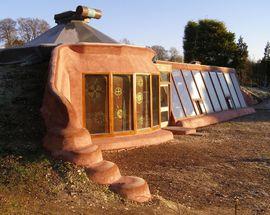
[[0, 18, 17, 47]]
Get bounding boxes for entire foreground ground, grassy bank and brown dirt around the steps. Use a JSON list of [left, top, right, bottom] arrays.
[[0, 106, 270, 215]]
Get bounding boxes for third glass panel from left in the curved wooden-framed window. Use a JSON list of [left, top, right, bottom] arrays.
[[136, 75, 151, 129]]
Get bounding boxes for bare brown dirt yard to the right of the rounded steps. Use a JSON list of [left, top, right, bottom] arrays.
[[105, 108, 270, 214]]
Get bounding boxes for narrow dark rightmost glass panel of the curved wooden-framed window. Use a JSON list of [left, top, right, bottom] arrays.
[[152, 75, 159, 126]]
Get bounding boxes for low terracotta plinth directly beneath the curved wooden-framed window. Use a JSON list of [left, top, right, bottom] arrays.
[[92, 129, 173, 150]]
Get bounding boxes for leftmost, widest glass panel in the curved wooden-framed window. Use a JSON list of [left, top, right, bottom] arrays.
[[85, 75, 109, 134]]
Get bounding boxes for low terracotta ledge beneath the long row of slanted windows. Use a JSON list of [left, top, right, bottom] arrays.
[[176, 107, 255, 128]]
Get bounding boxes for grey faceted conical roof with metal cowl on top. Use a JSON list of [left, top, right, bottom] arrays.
[[24, 6, 117, 47]]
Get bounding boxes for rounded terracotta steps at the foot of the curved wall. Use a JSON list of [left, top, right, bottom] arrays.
[[47, 144, 151, 202]]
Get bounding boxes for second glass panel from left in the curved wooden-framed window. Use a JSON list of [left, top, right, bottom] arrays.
[[113, 75, 133, 132]]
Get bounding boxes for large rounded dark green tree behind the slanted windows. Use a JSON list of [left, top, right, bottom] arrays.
[[184, 19, 237, 67]]
